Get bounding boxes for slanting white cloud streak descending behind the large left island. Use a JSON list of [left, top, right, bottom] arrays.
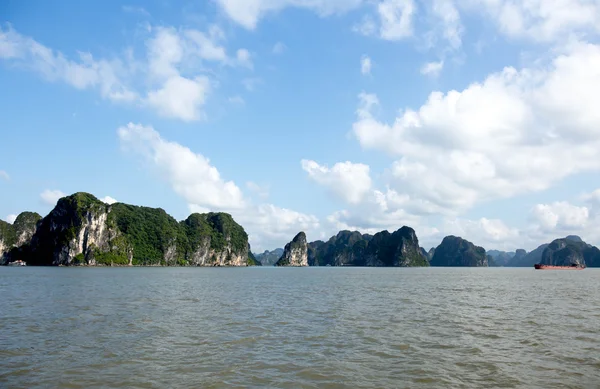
[[117, 123, 320, 250]]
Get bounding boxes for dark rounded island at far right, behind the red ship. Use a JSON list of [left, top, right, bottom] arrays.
[[541, 237, 600, 267]]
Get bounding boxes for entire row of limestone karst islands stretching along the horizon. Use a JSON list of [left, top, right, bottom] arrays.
[[0, 192, 600, 267]]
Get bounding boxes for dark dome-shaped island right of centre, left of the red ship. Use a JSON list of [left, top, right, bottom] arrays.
[[430, 236, 488, 267]]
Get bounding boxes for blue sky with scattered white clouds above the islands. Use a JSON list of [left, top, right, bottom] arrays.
[[0, 0, 600, 252]]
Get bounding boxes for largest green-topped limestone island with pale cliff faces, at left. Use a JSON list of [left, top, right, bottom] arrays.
[[9, 193, 249, 266]]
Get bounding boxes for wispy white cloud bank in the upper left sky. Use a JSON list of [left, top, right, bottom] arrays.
[[0, 24, 253, 121]]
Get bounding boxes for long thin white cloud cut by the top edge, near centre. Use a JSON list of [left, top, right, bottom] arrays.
[[216, 0, 362, 30]]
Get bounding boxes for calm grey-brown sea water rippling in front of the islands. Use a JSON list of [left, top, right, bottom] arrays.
[[0, 267, 600, 388]]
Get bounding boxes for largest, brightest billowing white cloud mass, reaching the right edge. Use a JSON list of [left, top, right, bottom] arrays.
[[353, 43, 600, 212]]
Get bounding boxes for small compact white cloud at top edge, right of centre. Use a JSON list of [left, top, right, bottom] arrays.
[[377, 0, 416, 40]]
